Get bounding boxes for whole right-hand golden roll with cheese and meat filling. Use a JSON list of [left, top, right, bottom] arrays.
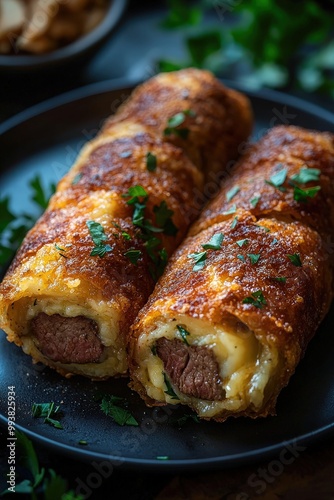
[[131, 126, 334, 421]]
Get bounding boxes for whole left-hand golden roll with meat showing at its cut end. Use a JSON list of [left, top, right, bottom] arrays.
[[0, 71, 251, 379]]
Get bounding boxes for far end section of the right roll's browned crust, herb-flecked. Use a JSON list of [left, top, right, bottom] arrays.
[[191, 126, 334, 235]]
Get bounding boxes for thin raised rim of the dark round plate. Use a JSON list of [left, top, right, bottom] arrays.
[[0, 78, 334, 472]]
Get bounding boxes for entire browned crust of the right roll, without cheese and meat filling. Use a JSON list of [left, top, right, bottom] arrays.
[[130, 126, 334, 421]]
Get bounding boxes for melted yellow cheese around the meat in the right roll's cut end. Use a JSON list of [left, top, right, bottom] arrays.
[[136, 316, 278, 417]]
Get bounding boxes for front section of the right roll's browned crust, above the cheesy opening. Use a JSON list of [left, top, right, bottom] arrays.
[[134, 214, 332, 356]]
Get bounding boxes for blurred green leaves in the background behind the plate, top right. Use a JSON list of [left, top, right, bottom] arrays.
[[159, 0, 334, 97]]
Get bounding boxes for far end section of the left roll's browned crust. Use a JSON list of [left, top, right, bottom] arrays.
[[105, 69, 253, 175]]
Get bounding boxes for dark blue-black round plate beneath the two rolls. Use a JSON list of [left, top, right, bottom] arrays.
[[0, 82, 334, 471]]
